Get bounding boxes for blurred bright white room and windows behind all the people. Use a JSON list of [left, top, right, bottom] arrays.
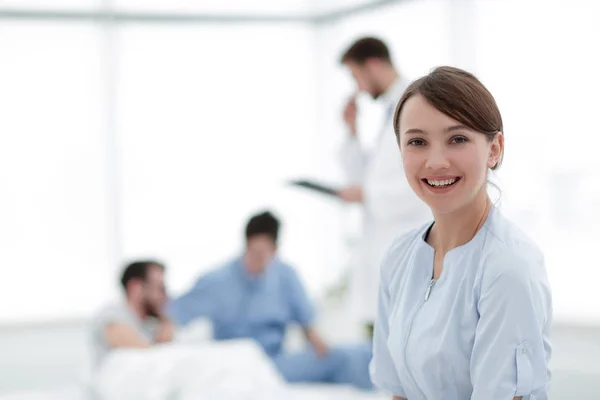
[[0, 0, 600, 398]]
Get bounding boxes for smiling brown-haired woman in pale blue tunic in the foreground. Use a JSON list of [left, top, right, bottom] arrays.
[[372, 67, 552, 400]]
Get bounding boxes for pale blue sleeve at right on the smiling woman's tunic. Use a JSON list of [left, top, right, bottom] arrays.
[[470, 249, 552, 400]]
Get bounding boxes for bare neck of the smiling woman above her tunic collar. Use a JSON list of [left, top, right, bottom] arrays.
[[427, 188, 492, 254]]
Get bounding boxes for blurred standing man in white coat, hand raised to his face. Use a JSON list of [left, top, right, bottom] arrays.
[[339, 37, 431, 334]]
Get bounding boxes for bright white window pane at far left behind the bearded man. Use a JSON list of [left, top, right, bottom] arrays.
[[0, 21, 109, 322]]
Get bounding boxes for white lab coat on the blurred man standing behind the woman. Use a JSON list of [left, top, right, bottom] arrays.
[[341, 79, 432, 323]]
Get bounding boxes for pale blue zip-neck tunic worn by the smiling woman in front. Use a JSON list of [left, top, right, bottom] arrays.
[[371, 208, 552, 400]]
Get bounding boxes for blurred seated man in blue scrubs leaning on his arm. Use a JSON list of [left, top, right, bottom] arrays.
[[169, 212, 372, 389]]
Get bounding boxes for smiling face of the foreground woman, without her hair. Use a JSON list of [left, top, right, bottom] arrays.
[[398, 95, 504, 214]]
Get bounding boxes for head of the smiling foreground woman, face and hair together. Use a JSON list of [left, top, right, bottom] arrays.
[[394, 67, 504, 216]]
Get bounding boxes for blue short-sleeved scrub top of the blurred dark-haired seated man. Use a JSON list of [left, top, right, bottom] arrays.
[[169, 258, 314, 356]]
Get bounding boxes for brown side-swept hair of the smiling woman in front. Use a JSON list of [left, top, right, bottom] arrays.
[[394, 67, 504, 169]]
